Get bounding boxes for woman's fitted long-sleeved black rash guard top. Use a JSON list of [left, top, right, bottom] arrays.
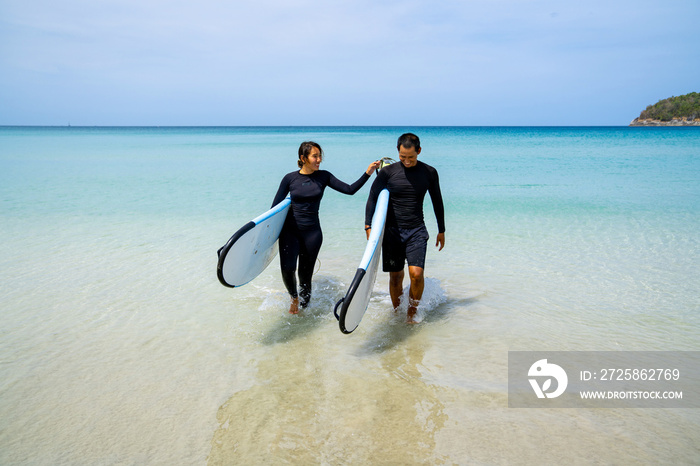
[[272, 170, 369, 230]]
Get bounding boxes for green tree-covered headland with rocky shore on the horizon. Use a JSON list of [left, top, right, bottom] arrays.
[[630, 92, 700, 126]]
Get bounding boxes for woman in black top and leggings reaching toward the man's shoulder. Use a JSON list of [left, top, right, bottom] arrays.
[[272, 142, 379, 314]]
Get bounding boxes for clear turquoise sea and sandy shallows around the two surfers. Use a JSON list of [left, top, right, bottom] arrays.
[[0, 127, 700, 465]]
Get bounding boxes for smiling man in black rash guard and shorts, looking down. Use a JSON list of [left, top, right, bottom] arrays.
[[365, 133, 445, 324]]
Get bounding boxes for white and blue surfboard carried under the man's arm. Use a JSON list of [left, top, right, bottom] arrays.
[[333, 189, 389, 333]]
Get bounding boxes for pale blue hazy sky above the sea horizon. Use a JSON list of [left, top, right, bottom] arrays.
[[0, 0, 700, 126]]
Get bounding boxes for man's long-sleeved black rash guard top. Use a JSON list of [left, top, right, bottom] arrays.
[[365, 161, 445, 233]]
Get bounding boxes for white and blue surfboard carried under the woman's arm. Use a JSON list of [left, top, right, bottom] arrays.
[[216, 198, 292, 288]]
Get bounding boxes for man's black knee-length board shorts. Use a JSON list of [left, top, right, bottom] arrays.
[[382, 225, 430, 272]]
